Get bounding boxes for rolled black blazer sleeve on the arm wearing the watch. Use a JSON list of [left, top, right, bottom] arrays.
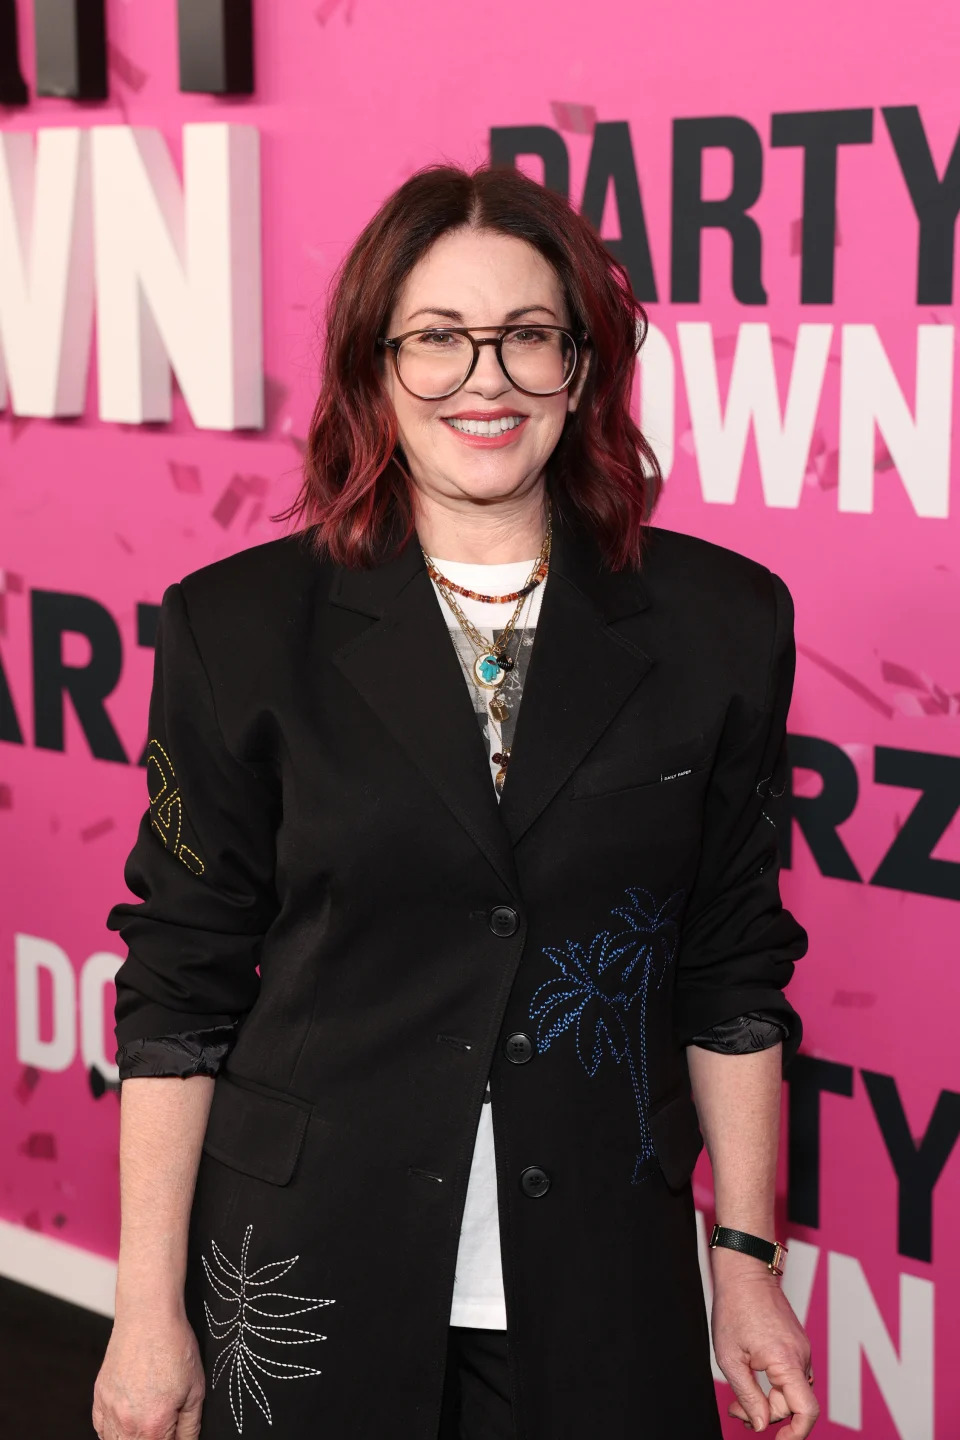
[[675, 575, 807, 1064]]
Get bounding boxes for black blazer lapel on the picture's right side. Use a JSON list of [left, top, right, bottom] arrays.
[[499, 507, 653, 845]]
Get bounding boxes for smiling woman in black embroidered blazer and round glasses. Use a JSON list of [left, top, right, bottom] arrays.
[[94, 167, 816, 1440]]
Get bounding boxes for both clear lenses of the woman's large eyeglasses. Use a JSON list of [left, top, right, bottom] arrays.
[[397, 328, 576, 400]]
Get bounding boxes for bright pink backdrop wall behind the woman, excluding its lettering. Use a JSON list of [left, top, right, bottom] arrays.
[[0, 0, 960, 1440]]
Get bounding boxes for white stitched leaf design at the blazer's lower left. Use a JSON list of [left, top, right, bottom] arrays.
[[201, 1224, 335, 1434]]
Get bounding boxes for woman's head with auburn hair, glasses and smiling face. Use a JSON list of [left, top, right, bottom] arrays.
[[278, 166, 661, 567]]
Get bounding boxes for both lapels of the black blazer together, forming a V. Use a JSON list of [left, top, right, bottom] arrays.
[[328, 505, 652, 893]]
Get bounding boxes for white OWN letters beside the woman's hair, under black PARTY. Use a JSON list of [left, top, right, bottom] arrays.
[[638, 320, 956, 520]]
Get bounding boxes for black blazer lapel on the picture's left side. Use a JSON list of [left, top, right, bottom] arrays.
[[330, 524, 525, 894]]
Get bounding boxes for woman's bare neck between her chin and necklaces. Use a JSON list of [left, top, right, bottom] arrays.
[[415, 482, 547, 564]]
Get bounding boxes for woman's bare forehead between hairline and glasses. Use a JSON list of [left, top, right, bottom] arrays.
[[391, 229, 566, 324]]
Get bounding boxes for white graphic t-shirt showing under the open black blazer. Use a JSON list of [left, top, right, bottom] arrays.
[[433, 556, 547, 1331]]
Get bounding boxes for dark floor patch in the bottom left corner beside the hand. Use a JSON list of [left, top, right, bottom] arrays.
[[0, 1277, 112, 1440]]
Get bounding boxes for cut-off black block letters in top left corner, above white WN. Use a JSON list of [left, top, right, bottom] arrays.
[[0, 0, 253, 105]]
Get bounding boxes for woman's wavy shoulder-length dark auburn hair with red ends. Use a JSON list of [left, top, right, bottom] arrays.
[[273, 164, 662, 570]]
